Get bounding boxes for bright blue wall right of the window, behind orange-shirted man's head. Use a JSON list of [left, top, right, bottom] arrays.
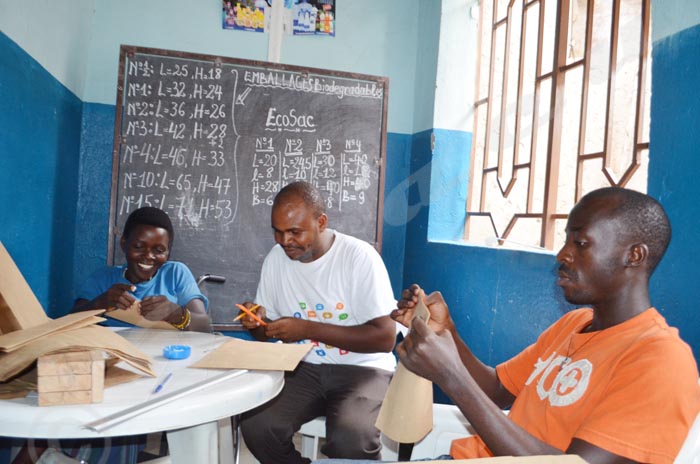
[[648, 23, 700, 360]]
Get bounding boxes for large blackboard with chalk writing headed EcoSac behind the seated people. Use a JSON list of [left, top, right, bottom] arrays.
[[108, 46, 388, 329]]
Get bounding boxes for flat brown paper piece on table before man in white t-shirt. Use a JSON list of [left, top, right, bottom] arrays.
[[190, 338, 312, 371]]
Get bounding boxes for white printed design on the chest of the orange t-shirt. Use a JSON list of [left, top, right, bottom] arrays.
[[525, 352, 593, 406]]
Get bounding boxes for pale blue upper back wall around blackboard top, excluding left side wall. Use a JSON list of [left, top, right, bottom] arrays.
[[84, 0, 426, 133]]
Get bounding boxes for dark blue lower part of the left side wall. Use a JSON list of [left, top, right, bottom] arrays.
[[0, 32, 81, 316]]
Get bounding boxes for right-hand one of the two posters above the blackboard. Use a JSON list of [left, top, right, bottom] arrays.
[[284, 0, 335, 36]]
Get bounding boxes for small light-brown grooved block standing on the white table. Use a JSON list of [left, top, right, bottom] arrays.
[[37, 350, 105, 406]]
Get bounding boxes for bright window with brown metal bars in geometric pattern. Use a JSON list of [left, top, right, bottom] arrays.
[[465, 0, 651, 250]]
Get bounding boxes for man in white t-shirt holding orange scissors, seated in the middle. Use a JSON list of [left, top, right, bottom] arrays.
[[241, 182, 396, 464]]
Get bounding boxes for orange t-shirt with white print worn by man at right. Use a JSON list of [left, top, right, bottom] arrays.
[[450, 308, 700, 464]]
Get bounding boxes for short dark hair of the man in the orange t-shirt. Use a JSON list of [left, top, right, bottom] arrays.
[[581, 187, 671, 275]]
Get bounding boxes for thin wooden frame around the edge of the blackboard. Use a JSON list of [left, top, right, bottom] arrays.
[[107, 45, 389, 330]]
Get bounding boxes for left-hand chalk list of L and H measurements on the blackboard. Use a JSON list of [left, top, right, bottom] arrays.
[[118, 57, 236, 227]]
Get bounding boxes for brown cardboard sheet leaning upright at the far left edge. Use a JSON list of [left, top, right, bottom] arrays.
[[0, 242, 50, 334]]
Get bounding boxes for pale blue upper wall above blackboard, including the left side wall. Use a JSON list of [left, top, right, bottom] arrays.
[[0, 0, 432, 134]]
